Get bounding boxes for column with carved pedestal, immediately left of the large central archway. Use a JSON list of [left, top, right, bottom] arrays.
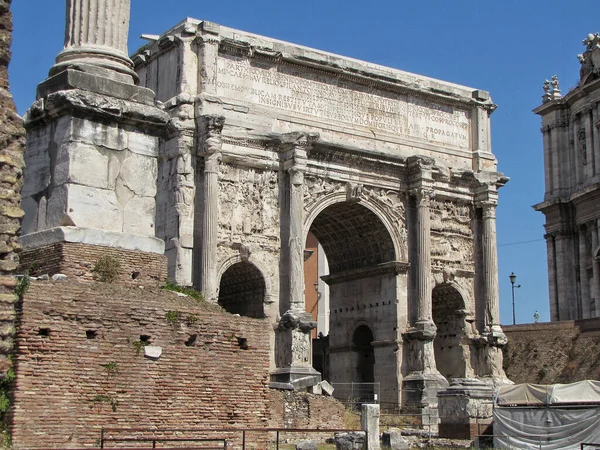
[[271, 133, 321, 389]]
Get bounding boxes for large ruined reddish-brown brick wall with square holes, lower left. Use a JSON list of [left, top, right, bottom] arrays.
[[12, 280, 270, 448]]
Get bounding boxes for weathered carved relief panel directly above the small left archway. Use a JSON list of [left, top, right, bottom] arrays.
[[219, 165, 279, 242]]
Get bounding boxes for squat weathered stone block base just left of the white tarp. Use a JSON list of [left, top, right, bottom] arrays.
[[438, 378, 494, 440]]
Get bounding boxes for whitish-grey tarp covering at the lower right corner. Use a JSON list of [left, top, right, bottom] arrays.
[[494, 381, 600, 450]]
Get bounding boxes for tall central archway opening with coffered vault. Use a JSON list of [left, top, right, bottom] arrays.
[[309, 201, 399, 402]]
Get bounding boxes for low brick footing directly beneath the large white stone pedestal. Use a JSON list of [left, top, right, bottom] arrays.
[[20, 242, 167, 286]]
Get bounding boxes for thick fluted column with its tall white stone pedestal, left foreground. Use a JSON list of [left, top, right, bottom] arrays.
[[21, 0, 169, 283]]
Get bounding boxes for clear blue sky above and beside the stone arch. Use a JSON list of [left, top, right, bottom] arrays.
[[9, 0, 600, 324]]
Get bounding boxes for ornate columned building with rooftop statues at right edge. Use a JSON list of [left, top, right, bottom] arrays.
[[534, 33, 600, 321]]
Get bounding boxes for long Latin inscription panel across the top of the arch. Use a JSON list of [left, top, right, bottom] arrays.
[[217, 56, 470, 148]]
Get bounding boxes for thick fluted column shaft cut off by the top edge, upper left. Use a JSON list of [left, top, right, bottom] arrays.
[[50, 0, 137, 83]]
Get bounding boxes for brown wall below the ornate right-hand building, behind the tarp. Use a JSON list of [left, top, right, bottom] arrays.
[[503, 318, 600, 384]]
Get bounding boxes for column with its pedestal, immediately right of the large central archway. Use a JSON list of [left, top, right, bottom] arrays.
[[403, 157, 448, 426]]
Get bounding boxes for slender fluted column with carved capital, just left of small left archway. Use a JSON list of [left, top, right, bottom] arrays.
[[200, 116, 225, 302]]
